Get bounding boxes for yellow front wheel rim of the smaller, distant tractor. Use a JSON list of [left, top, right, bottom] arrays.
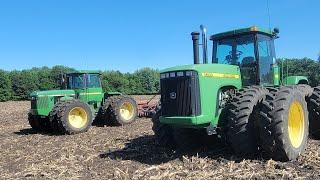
[[68, 107, 88, 129]]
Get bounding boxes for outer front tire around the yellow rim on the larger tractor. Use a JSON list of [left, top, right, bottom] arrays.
[[259, 86, 308, 161]]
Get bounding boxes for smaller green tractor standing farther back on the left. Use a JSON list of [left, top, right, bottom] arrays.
[[28, 71, 137, 134]]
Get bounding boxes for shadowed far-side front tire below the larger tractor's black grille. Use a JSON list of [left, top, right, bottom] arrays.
[[152, 110, 176, 149]]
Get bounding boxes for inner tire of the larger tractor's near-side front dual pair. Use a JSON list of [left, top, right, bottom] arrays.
[[227, 86, 268, 156]]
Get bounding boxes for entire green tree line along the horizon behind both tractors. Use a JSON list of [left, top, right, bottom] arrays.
[[0, 58, 320, 101]]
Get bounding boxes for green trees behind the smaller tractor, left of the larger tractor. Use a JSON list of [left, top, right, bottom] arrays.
[[0, 66, 160, 101]]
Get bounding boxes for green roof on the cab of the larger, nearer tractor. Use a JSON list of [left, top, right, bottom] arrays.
[[210, 26, 275, 40]]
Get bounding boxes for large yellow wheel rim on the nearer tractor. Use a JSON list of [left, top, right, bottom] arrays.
[[288, 101, 305, 148]]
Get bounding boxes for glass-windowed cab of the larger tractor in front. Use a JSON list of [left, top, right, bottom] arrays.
[[211, 27, 279, 86]]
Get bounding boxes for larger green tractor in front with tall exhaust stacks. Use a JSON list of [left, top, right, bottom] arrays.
[[153, 26, 320, 161]]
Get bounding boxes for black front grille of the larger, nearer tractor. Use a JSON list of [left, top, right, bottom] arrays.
[[161, 71, 201, 116]]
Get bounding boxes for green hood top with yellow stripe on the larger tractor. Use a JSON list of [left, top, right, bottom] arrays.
[[160, 64, 240, 77]]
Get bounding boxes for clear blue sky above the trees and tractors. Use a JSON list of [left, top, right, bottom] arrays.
[[0, 0, 320, 72]]
